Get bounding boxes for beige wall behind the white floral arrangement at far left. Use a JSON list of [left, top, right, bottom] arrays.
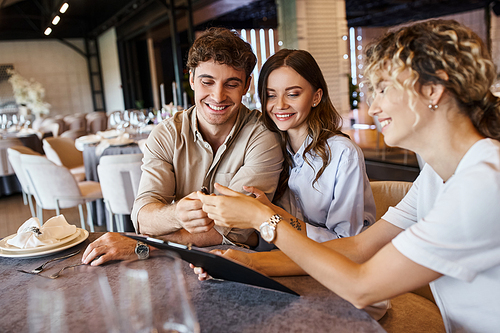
[[0, 40, 94, 116]]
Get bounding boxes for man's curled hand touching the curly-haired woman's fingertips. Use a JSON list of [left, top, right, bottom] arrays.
[[175, 192, 215, 234]]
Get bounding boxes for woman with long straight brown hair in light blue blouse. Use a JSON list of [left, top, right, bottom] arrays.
[[245, 49, 375, 242]]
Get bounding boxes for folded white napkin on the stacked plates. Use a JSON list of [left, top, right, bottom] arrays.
[[7, 215, 76, 249]]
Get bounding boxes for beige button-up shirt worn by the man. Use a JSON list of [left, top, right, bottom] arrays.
[[132, 105, 283, 242]]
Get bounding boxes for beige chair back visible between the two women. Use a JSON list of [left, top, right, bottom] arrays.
[[370, 181, 413, 221]]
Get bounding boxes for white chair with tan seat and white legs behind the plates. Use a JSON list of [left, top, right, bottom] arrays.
[[21, 155, 102, 231]]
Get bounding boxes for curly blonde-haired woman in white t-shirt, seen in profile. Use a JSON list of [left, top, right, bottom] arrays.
[[195, 20, 500, 332]]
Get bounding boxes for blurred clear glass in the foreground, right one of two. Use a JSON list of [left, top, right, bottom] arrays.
[[118, 253, 200, 333]]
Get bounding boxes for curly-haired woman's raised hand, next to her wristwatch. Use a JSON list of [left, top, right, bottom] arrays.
[[198, 183, 275, 229]]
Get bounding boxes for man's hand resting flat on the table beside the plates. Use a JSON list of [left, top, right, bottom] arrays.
[[82, 232, 137, 266]]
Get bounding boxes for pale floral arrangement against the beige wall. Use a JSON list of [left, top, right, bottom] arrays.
[[7, 69, 50, 116]]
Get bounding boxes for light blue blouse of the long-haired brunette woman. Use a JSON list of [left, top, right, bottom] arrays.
[[288, 135, 375, 242]]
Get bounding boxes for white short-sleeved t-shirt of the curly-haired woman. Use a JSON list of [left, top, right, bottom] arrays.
[[382, 139, 500, 332]]
